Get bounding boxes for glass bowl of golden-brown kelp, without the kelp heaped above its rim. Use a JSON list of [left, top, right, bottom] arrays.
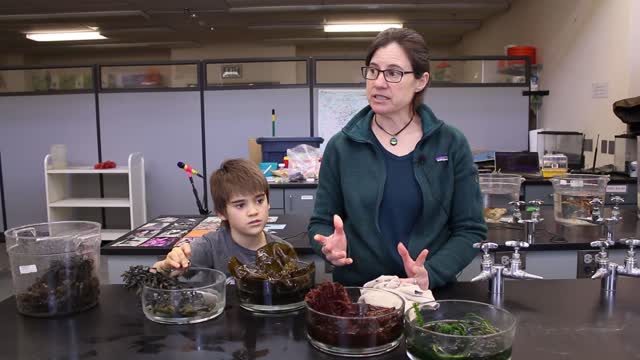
[[235, 261, 316, 313]]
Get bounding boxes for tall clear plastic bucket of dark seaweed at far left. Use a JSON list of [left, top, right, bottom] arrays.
[[5, 221, 101, 317]]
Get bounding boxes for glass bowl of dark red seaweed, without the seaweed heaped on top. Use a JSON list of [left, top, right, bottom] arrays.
[[307, 287, 404, 356]]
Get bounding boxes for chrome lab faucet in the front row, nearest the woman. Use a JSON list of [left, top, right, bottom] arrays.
[[471, 241, 542, 294]]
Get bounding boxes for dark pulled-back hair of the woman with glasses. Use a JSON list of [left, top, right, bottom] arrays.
[[365, 28, 431, 109]]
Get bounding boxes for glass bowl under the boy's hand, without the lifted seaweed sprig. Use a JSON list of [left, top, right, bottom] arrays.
[[142, 268, 226, 324]]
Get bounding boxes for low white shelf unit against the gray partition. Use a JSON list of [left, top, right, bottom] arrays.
[[44, 153, 147, 241]]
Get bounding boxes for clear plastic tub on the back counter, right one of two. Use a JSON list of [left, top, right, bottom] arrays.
[[551, 174, 609, 225]]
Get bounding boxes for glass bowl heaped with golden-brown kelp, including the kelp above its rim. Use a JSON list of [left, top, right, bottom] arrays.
[[229, 242, 316, 313]]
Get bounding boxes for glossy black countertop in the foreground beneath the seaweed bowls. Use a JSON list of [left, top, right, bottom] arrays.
[[0, 278, 640, 360]]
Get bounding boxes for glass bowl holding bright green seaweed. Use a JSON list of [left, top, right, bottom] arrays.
[[405, 300, 517, 360]]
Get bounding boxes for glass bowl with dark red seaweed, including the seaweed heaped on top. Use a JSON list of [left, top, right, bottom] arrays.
[[305, 283, 404, 356]]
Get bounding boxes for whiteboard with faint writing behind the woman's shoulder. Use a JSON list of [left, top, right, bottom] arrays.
[[318, 89, 369, 151]]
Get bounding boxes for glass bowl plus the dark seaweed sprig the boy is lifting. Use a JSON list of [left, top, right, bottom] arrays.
[[122, 266, 226, 324]]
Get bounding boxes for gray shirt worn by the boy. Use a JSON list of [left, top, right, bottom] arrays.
[[190, 226, 285, 276]]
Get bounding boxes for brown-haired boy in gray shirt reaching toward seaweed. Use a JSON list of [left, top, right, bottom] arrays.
[[154, 159, 282, 275]]
